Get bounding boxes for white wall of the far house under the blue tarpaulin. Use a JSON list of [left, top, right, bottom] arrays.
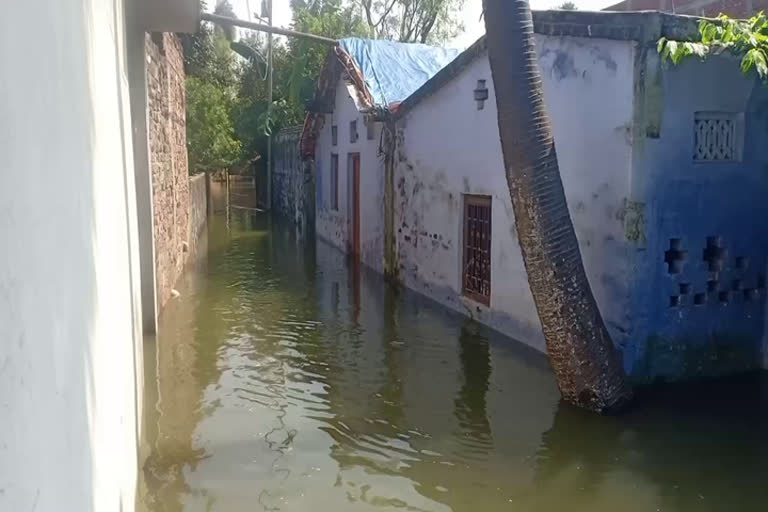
[[315, 80, 384, 272]]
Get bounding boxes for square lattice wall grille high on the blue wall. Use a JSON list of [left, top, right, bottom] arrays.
[[693, 112, 742, 162]]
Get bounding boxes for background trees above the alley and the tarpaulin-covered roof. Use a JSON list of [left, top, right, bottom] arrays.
[[181, 0, 464, 174]]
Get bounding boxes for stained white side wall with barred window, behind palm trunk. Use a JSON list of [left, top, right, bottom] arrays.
[[395, 35, 634, 350]]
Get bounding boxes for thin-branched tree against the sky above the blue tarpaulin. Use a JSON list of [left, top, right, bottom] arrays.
[[355, 0, 464, 43]]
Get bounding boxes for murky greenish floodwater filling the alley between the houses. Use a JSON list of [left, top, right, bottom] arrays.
[[139, 202, 768, 512]]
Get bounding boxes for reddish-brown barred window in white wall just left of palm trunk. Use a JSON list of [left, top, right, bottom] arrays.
[[462, 195, 491, 306]]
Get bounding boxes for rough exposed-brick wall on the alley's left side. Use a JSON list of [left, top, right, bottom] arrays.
[[145, 33, 190, 311]]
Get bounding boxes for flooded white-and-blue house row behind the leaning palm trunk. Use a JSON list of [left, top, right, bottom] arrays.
[[302, 11, 768, 381]]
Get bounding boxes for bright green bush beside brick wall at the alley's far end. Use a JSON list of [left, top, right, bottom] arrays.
[[186, 76, 241, 172]]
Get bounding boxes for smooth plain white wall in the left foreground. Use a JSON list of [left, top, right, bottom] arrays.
[[0, 0, 141, 512]]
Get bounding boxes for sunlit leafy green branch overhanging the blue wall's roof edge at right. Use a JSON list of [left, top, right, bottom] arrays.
[[657, 11, 768, 82]]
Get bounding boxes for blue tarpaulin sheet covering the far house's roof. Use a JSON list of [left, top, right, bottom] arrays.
[[339, 37, 461, 107]]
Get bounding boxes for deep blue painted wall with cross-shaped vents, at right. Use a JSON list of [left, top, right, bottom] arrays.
[[624, 57, 768, 380]]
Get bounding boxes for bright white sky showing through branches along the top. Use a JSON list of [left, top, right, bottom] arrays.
[[219, 0, 618, 48]]
